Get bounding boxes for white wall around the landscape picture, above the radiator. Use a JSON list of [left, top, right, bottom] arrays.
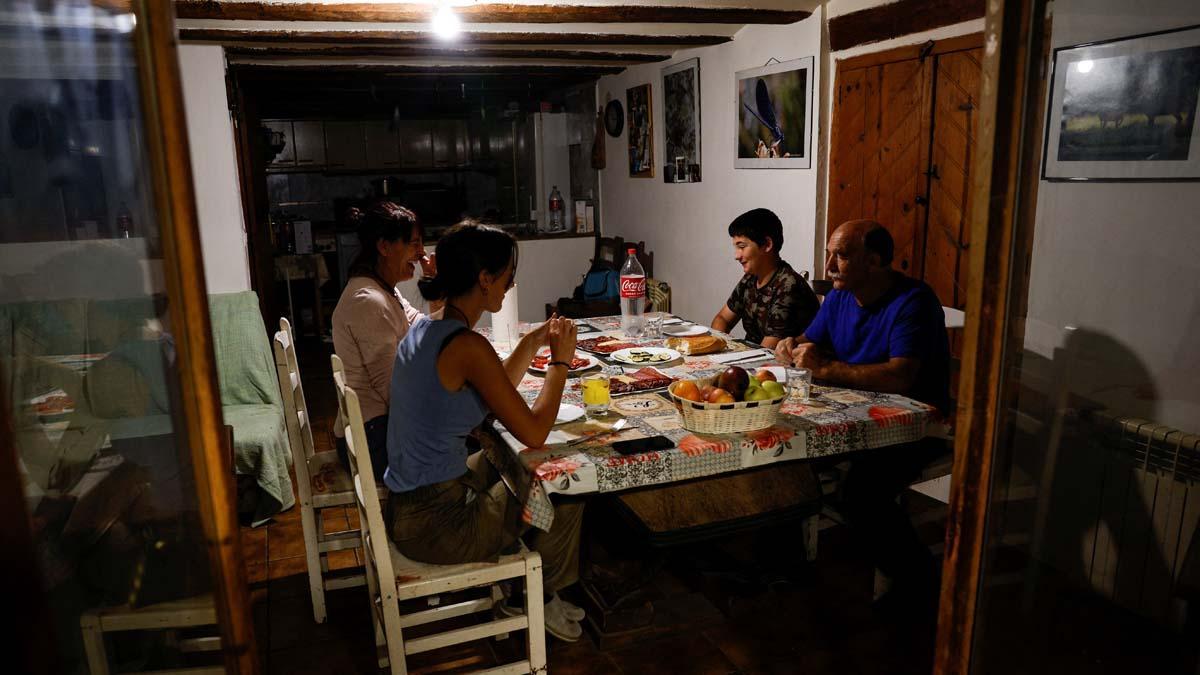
[[1026, 0, 1200, 432]]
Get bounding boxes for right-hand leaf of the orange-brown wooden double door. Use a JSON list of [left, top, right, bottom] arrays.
[[923, 49, 983, 309]]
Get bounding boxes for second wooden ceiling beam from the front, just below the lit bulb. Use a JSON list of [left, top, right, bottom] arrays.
[[179, 28, 732, 47]]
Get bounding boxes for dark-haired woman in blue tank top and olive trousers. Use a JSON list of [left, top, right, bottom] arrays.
[[384, 222, 583, 641]]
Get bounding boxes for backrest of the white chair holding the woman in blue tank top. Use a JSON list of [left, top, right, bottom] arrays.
[[330, 354, 400, 634]]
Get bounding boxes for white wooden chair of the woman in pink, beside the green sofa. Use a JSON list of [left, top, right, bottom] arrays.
[[274, 318, 366, 623]]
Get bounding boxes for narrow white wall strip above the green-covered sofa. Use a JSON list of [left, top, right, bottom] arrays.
[[179, 44, 250, 293]]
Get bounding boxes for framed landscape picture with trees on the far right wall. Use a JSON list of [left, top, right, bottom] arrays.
[[1042, 26, 1200, 181]]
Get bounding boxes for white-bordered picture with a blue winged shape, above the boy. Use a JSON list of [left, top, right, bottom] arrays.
[[733, 56, 814, 168]]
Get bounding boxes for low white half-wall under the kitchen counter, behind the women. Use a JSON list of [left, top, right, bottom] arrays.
[[397, 237, 595, 327]]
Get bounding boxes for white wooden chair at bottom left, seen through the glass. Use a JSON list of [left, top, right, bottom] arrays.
[[79, 595, 224, 675]]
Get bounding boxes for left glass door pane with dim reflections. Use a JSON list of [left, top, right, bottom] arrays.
[[0, 2, 216, 673]]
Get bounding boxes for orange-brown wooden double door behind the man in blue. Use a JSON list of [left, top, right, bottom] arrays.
[[827, 35, 982, 309]]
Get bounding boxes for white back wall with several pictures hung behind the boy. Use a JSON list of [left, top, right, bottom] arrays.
[[596, 10, 826, 323]]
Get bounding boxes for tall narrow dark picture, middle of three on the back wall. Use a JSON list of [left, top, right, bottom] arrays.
[[662, 59, 700, 183]]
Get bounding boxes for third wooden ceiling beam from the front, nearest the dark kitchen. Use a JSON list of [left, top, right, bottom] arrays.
[[226, 44, 671, 64]]
